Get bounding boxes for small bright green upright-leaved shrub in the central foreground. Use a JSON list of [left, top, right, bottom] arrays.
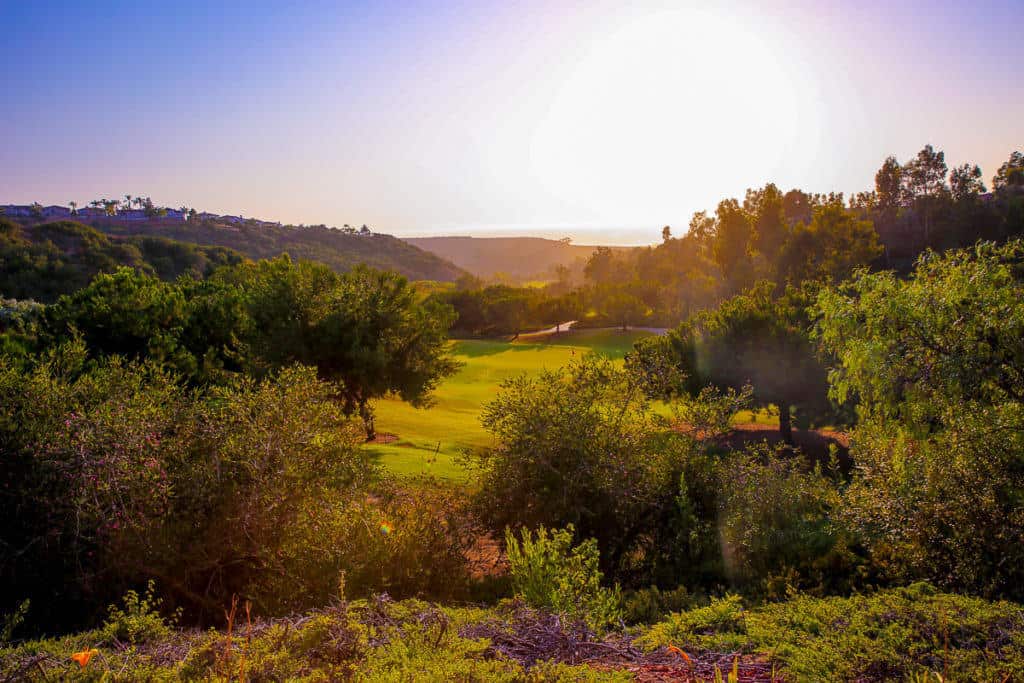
[[505, 525, 622, 629]]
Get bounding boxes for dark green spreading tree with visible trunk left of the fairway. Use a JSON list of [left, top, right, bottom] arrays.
[[230, 256, 459, 439]]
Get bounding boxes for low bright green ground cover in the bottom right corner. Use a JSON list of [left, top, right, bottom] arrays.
[[641, 584, 1024, 681]]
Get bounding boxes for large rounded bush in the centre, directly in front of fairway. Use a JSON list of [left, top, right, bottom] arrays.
[[476, 355, 685, 581]]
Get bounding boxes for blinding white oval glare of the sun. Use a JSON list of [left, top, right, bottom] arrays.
[[532, 10, 809, 220]]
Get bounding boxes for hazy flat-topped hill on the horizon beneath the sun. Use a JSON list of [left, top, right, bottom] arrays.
[[406, 237, 633, 281]]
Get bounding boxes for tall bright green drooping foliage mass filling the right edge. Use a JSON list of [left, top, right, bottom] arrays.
[[817, 242, 1024, 597]]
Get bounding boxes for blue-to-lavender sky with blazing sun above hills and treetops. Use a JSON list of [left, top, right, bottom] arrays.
[[0, 0, 1024, 244]]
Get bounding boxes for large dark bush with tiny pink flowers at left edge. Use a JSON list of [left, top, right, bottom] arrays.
[[0, 344, 372, 629]]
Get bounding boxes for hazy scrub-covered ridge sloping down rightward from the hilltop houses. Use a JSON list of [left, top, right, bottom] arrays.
[[74, 218, 462, 282]]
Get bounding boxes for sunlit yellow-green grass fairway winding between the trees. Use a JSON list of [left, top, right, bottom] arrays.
[[367, 330, 650, 482]]
